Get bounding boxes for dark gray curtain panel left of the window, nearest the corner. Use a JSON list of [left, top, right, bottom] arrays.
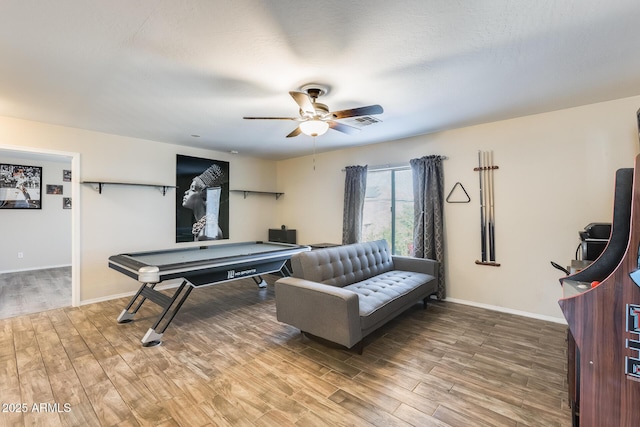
[[342, 166, 367, 245]]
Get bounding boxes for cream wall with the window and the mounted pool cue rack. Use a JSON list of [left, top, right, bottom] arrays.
[[277, 97, 640, 320]]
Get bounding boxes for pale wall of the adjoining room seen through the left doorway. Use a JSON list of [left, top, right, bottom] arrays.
[[0, 154, 71, 273]]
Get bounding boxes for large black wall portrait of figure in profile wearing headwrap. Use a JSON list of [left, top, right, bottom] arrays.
[[176, 154, 229, 242]]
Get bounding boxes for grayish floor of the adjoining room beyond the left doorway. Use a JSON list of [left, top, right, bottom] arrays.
[[0, 267, 71, 319]]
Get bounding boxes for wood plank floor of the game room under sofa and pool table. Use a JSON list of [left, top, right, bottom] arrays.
[[0, 276, 571, 427]]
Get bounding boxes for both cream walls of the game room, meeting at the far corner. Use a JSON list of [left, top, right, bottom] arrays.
[[0, 97, 640, 319]]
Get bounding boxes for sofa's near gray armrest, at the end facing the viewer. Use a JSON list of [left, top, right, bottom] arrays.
[[275, 277, 362, 348]]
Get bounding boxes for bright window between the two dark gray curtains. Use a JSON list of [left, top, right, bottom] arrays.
[[362, 168, 413, 255]]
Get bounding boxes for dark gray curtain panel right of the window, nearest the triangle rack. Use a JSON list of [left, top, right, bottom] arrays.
[[409, 156, 446, 300]]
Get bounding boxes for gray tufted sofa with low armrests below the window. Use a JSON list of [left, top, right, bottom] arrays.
[[275, 240, 438, 352]]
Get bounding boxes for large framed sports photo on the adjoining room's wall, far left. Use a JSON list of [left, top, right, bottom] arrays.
[[0, 163, 42, 209]]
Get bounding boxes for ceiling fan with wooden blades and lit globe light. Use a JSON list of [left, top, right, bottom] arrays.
[[243, 83, 383, 138]]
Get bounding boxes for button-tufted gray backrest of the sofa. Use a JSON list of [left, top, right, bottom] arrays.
[[291, 240, 393, 287]]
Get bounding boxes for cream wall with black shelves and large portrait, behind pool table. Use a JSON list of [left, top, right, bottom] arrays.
[[0, 117, 281, 302]]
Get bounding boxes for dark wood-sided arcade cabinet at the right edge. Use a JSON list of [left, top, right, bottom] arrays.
[[560, 156, 640, 427]]
